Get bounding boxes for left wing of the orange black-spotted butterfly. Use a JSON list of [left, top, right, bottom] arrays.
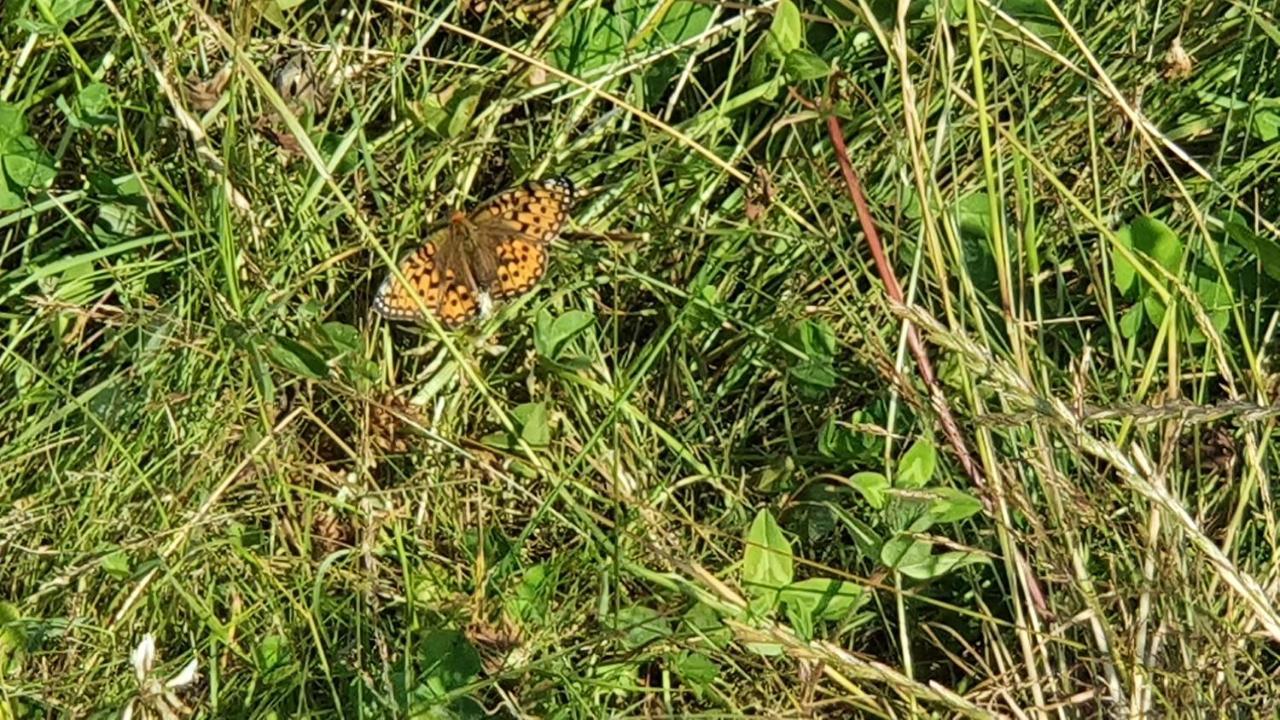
[[374, 234, 480, 328]]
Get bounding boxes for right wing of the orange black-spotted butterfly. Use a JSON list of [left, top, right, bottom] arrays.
[[471, 178, 573, 300]]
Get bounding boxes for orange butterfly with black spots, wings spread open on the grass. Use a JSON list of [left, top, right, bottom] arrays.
[[374, 178, 575, 329]]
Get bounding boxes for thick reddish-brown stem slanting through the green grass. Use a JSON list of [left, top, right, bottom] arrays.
[[827, 114, 992, 497]]
